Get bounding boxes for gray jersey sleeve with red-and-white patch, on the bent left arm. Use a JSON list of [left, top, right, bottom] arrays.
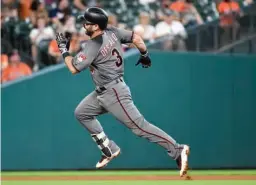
[[72, 44, 99, 71]]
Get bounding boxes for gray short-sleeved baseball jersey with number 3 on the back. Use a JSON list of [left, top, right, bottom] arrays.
[[73, 27, 133, 86]]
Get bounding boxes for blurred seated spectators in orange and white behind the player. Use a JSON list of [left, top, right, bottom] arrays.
[[1, 0, 253, 83]]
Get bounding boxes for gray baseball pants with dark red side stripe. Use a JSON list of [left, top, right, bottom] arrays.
[[75, 78, 183, 160]]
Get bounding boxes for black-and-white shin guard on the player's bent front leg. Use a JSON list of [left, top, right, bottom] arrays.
[[92, 131, 112, 157]]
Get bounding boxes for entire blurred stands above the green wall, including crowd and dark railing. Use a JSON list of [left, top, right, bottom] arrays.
[[1, 0, 256, 76]]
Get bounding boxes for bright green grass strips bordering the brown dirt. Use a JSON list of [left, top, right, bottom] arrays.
[[1, 170, 256, 185]]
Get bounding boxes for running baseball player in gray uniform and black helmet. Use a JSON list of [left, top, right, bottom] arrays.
[[56, 7, 189, 177]]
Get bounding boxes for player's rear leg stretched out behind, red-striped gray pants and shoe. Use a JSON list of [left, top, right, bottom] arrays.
[[99, 83, 189, 176]]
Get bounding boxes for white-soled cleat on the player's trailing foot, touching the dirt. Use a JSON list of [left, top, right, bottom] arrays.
[[177, 145, 190, 177]]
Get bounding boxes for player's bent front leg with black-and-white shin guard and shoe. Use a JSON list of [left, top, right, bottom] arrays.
[[75, 92, 120, 168]]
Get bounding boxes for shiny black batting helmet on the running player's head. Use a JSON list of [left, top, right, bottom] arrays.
[[78, 7, 108, 30]]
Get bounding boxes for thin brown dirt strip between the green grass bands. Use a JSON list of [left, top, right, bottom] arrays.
[[2, 175, 256, 181]]
